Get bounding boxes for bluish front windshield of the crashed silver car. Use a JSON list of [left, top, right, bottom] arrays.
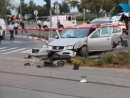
[[61, 29, 89, 38]]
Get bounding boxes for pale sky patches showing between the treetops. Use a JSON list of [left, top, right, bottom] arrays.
[[24, 0, 77, 12]]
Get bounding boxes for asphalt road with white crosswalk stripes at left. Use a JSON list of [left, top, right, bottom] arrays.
[[0, 35, 45, 58]]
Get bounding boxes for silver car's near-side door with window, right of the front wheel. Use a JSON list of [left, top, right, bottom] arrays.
[[88, 27, 112, 51]]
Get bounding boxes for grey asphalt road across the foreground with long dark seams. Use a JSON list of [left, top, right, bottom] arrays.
[[0, 62, 130, 98]]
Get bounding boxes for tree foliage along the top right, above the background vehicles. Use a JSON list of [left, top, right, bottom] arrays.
[[68, 0, 128, 17]]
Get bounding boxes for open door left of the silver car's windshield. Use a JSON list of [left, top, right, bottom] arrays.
[[48, 30, 60, 42]]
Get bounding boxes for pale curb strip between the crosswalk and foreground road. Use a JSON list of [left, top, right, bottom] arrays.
[[0, 57, 44, 65]]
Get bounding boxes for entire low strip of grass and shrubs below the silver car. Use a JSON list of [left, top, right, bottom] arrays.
[[72, 51, 130, 68]]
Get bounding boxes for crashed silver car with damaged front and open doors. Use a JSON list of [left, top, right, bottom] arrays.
[[48, 24, 122, 57]]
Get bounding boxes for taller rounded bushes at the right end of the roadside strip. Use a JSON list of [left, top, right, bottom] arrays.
[[89, 51, 130, 67]]
